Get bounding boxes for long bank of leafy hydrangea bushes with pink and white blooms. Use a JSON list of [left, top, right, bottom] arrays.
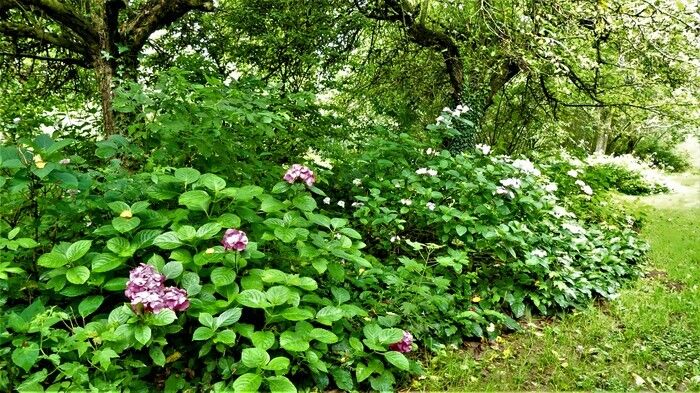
[[0, 130, 646, 392]]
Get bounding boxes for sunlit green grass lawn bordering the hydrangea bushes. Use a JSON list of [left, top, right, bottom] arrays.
[[412, 208, 700, 391]]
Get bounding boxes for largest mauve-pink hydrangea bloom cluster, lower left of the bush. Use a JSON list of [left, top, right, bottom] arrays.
[[124, 263, 190, 313]]
